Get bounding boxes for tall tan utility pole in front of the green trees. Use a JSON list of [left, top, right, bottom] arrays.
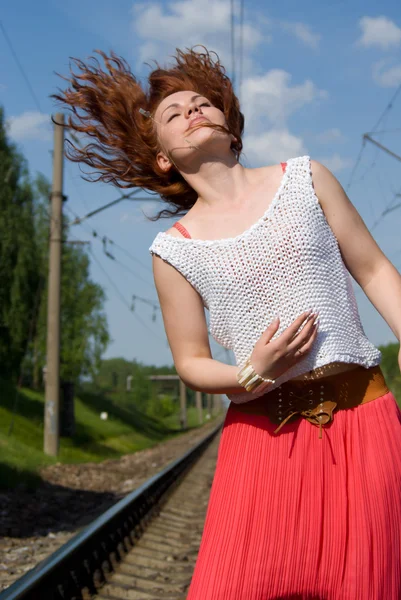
[[43, 113, 64, 456]]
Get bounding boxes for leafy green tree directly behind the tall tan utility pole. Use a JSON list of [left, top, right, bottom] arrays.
[[27, 175, 109, 386]]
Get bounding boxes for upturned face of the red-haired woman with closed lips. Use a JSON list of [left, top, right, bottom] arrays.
[[154, 91, 235, 171]]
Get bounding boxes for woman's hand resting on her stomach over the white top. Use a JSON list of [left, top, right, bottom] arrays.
[[250, 312, 318, 379]]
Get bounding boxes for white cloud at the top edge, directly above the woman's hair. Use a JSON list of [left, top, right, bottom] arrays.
[[131, 0, 264, 69]]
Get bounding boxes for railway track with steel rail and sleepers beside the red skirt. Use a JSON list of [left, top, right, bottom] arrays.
[[0, 425, 221, 600]]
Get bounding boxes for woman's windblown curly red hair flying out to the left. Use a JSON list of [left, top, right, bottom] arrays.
[[52, 46, 244, 220]]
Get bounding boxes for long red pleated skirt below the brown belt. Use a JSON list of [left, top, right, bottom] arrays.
[[187, 392, 401, 600]]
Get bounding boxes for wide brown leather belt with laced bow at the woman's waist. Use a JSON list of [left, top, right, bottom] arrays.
[[230, 365, 389, 438]]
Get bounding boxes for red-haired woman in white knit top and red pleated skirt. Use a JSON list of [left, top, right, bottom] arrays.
[[55, 49, 401, 600]]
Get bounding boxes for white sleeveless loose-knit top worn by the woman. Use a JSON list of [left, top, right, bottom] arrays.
[[149, 156, 381, 403]]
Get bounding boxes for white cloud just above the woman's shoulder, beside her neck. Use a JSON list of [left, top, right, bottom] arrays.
[[244, 129, 306, 167]]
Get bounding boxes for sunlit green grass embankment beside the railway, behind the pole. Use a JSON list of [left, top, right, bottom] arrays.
[[0, 381, 220, 489]]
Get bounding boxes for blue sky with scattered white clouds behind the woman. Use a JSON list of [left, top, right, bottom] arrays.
[[0, 0, 401, 365]]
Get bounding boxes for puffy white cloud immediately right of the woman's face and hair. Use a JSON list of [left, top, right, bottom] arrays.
[[241, 69, 328, 131]]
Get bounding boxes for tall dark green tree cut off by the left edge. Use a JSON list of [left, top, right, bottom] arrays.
[[0, 107, 40, 378]]
